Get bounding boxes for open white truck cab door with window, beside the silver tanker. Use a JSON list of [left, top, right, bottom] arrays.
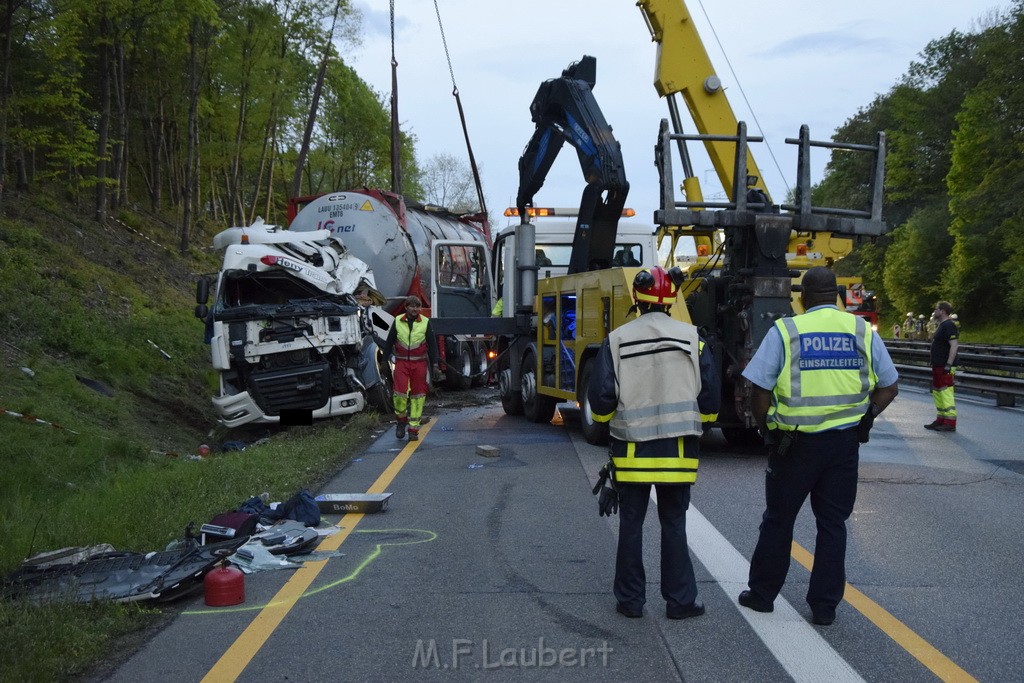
[[430, 240, 495, 317]]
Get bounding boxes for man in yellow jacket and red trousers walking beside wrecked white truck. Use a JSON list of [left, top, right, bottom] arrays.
[[381, 294, 441, 441]]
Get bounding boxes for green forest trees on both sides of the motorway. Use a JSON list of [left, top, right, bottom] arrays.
[[0, 0, 1024, 323]]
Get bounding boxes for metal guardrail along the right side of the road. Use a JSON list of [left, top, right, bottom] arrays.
[[886, 339, 1024, 407]]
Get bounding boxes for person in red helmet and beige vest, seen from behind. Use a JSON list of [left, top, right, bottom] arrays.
[[588, 266, 721, 620]]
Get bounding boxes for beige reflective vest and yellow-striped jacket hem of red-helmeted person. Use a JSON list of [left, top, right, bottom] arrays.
[[608, 313, 702, 483]]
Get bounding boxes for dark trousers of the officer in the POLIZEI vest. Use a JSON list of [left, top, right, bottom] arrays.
[[749, 428, 860, 610]]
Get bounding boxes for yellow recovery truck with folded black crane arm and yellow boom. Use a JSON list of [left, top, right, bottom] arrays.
[[479, 0, 889, 443]]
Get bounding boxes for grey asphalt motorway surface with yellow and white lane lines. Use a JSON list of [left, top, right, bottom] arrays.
[[110, 387, 1024, 682]]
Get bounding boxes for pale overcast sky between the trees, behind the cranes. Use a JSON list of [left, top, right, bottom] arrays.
[[344, 0, 1009, 237]]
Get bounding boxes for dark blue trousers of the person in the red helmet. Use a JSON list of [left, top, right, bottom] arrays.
[[614, 483, 697, 609]]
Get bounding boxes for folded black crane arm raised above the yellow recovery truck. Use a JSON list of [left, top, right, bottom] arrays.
[[516, 55, 630, 273]]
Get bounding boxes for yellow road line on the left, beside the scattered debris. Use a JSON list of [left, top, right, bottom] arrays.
[[203, 420, 435, 683]]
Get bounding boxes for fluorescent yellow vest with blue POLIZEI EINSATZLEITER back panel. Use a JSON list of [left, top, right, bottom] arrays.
[[767, 307, 878, 432]]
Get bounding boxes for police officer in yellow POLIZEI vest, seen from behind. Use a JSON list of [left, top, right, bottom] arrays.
[[739, 266, 899, 626]]
